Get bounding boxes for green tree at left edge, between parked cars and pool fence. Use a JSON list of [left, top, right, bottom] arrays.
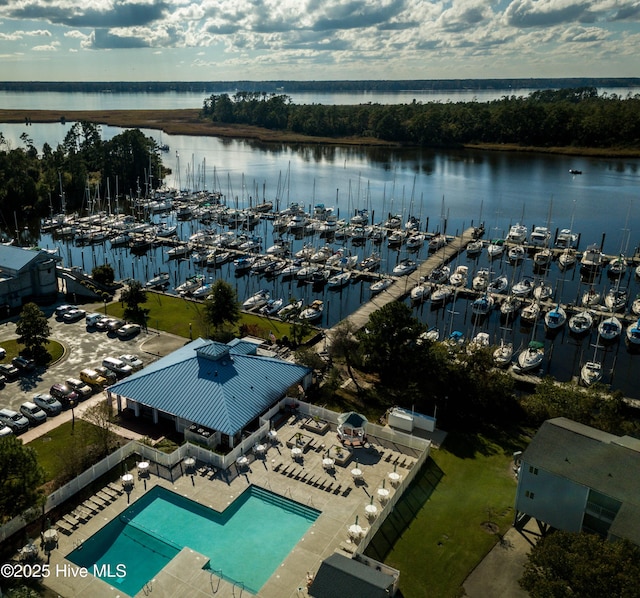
[[0, 435, 44, 520]]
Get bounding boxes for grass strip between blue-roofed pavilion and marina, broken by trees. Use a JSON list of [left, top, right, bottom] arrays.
[[107, 292, 311, 339]]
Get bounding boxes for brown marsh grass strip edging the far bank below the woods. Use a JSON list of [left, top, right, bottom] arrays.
[[0, 108, 640, 158]]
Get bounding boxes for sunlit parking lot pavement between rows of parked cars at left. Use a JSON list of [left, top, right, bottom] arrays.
[[0, 306, 185, 436]]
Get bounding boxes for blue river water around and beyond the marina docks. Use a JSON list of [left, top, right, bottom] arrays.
[[0, 94, 640, 398]]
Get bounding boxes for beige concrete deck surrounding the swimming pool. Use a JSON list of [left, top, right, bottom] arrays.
[[40, 421, 428, 598]]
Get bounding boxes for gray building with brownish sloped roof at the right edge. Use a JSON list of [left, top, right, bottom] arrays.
[[515, 418, 640, 545]]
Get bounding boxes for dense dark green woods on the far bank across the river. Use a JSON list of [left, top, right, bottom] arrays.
[[201, 86, 640, 149]]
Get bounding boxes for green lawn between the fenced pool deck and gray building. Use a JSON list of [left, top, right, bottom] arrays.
[[367, 435, 524, 598]]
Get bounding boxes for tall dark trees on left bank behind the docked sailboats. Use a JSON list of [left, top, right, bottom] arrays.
[[0, 122, 165, 218]]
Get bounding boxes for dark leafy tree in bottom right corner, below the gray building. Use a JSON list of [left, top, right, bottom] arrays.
[[520, 532, 640, 598]]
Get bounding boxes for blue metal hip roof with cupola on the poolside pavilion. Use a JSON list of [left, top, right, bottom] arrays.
[[109, 339, 310, 435]]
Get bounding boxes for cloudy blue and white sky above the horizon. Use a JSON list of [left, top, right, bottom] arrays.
[[0, 0, 640, 81]]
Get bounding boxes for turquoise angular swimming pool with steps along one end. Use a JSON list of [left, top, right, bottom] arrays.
[[67, 486, 320, 596]]
